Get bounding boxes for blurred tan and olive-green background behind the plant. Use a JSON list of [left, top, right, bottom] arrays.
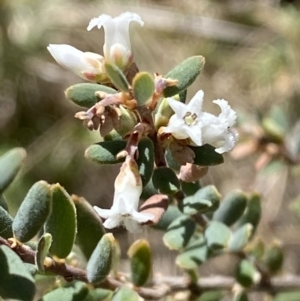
[[0, 0, 300, 290]]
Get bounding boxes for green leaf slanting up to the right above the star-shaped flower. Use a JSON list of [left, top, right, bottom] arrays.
[[163, 55, 205, 97]]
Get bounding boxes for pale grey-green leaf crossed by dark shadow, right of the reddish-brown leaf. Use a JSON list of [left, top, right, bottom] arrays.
[[182, 185, 220, 215]]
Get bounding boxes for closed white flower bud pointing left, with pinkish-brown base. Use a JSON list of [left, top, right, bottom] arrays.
[[47, 44, 107, 82]]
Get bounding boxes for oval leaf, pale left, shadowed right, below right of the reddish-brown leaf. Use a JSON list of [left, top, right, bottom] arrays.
[[163, 215, 196, 250]]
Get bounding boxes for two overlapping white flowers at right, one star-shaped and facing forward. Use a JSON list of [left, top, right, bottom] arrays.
[[163, 90, 238, 154]]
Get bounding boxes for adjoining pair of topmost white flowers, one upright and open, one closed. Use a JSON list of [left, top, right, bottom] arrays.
[[48, 12, 144, 82]]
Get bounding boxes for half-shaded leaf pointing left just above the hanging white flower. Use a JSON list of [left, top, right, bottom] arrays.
[[84, 140, 126, 164]]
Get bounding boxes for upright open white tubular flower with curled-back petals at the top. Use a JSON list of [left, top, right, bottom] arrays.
[[87, 12, 144, 69]]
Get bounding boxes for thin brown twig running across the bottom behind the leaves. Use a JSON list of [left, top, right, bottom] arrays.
[[0, 237, 300, 300]]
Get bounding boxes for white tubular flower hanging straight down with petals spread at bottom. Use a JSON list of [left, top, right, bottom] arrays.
[[94, 156, 154, 233]]
